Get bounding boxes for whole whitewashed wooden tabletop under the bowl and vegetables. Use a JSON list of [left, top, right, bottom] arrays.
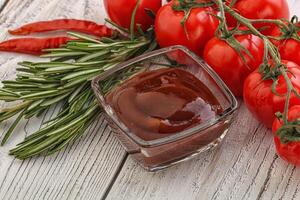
[[0, 0, 300, 200]]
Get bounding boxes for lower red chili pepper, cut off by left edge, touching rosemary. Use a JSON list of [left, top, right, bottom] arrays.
[[0, 37, 72, 55]]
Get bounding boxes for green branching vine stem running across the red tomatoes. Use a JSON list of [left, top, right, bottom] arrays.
[[173, 0, 300, 143]]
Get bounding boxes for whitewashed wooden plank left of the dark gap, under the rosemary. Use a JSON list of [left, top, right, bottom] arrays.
[[0, 0, 126, 199]]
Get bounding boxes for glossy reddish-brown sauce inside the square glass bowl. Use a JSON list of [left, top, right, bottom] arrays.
[[106, 68, 222, 140]]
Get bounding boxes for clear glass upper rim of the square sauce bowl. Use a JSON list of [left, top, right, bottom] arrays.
[[91, 45, 238, 147]]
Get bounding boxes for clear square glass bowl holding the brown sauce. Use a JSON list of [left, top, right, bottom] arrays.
[[92, 46, 238, 171]]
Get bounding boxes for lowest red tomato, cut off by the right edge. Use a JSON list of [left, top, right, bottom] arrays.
[[273, 105, 300, 166]]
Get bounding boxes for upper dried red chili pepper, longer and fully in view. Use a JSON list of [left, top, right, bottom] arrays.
[[8, 19, 113, 37]]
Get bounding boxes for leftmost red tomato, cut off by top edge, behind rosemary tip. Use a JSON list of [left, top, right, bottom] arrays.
[[104, 0, 162, 31]]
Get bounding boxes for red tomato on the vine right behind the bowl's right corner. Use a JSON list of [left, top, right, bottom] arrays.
[[203, 34, 264, 97]]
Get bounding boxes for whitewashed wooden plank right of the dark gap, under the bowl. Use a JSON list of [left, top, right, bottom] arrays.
[[107, 0, 300, 200]]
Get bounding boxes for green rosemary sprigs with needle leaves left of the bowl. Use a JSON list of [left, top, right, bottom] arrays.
[[0, 33, 151, 159]]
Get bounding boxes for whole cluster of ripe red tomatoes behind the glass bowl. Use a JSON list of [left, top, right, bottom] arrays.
[[104, 0, 300, 165]]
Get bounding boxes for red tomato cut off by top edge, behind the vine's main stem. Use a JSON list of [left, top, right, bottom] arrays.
[[227, 0, 290, 34]]
